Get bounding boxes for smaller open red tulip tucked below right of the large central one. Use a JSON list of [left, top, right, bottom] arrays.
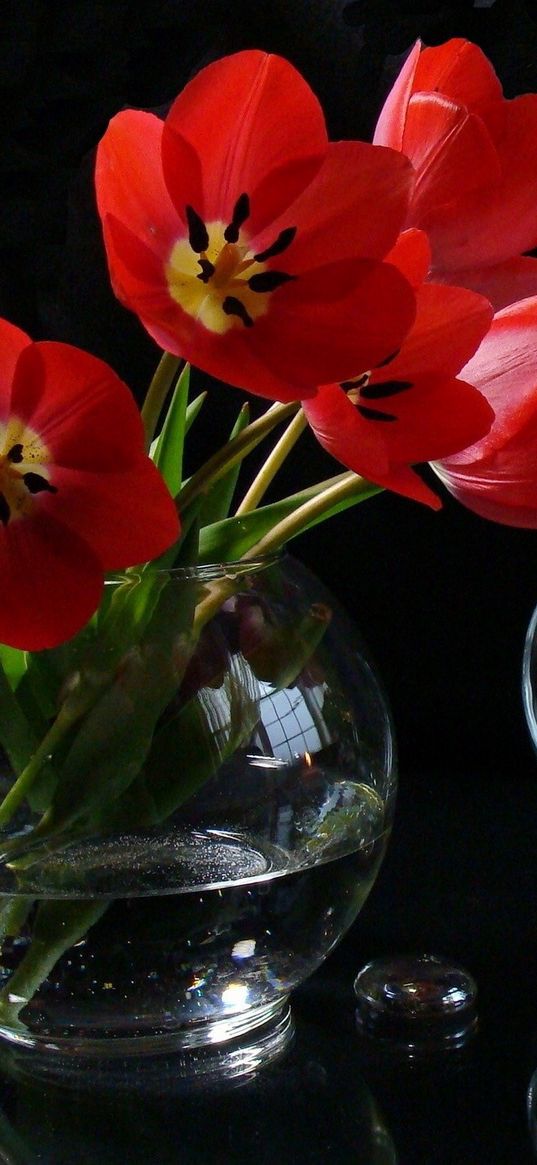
[[303, 231, 493, 508]]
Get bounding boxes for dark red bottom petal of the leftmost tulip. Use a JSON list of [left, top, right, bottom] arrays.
[[0, 511, 103, 651]]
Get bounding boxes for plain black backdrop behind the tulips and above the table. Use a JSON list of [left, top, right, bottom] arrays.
[[0, 0, 537, 781]]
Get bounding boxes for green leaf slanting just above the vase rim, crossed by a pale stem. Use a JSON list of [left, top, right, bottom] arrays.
[[199, 475, 380, 563]]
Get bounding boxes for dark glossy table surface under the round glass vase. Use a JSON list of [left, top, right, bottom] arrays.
[[0, 761, 537, 1165]]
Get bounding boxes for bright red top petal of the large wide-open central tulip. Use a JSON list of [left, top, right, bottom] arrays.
[[162, 50, 327, 231]]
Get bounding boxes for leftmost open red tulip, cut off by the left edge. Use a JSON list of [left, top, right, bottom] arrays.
[[0, 320, 178, 651]]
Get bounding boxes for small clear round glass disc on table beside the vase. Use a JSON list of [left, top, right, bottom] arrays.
[[354, 954, 478, 1054]]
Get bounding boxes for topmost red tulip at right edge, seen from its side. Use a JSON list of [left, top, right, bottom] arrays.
[[374, 40, 537, 309]]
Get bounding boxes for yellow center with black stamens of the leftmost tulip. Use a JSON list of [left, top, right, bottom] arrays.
[[0, 417, 56, 525]]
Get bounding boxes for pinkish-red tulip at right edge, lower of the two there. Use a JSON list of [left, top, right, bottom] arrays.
[[433, 297, 537, 528]]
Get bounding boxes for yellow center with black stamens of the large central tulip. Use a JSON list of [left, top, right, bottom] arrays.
[[165, 195, 296, 336]]
